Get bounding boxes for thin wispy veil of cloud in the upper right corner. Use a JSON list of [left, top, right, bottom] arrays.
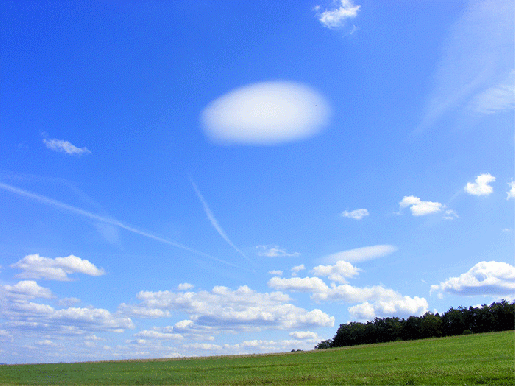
[[417, 0, 514, 131]]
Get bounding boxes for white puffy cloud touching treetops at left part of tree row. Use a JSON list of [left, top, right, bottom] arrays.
[[349, 296, 428, 321]]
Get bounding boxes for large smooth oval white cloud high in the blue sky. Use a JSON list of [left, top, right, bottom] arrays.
[[202, 82, 330, 144]]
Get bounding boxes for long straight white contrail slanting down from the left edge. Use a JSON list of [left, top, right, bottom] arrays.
[[0, 182, 241, 268]]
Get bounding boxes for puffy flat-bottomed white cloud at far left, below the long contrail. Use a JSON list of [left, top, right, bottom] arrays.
[[11, 254, 105, 281]]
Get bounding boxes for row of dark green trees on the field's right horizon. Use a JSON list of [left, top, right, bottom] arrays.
[[315, 300, 515, 349]]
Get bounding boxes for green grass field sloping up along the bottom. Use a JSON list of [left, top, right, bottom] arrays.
[[0, 331, 515, 385]]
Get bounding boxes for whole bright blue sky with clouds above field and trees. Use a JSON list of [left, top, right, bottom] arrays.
[[0, 0, 515, 363]]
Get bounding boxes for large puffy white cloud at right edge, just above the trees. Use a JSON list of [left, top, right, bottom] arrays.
[[431, 261, 515, 296]]
